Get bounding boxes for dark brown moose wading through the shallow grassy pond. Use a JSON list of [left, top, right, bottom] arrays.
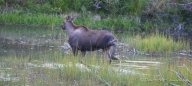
[[61, 16, 118, 64]]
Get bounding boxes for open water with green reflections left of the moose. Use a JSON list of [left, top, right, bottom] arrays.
[[0, 26, 65, 56]]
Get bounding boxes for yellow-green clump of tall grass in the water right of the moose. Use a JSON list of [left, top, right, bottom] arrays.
[[128, 32, 190, 53]]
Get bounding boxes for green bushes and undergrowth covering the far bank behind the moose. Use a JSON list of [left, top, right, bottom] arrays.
[[0, 0, 192, 31]]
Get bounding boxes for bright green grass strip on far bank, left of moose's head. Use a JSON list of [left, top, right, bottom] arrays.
[[0, 12, 63, 26]]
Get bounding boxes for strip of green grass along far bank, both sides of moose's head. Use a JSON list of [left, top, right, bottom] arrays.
[[0, 11, 139, 30]]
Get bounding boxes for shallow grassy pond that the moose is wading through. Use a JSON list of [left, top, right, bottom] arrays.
[[0, 25, 192, 86]]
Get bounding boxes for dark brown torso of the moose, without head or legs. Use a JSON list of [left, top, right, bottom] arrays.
[[68, 29, 114, 51]]
